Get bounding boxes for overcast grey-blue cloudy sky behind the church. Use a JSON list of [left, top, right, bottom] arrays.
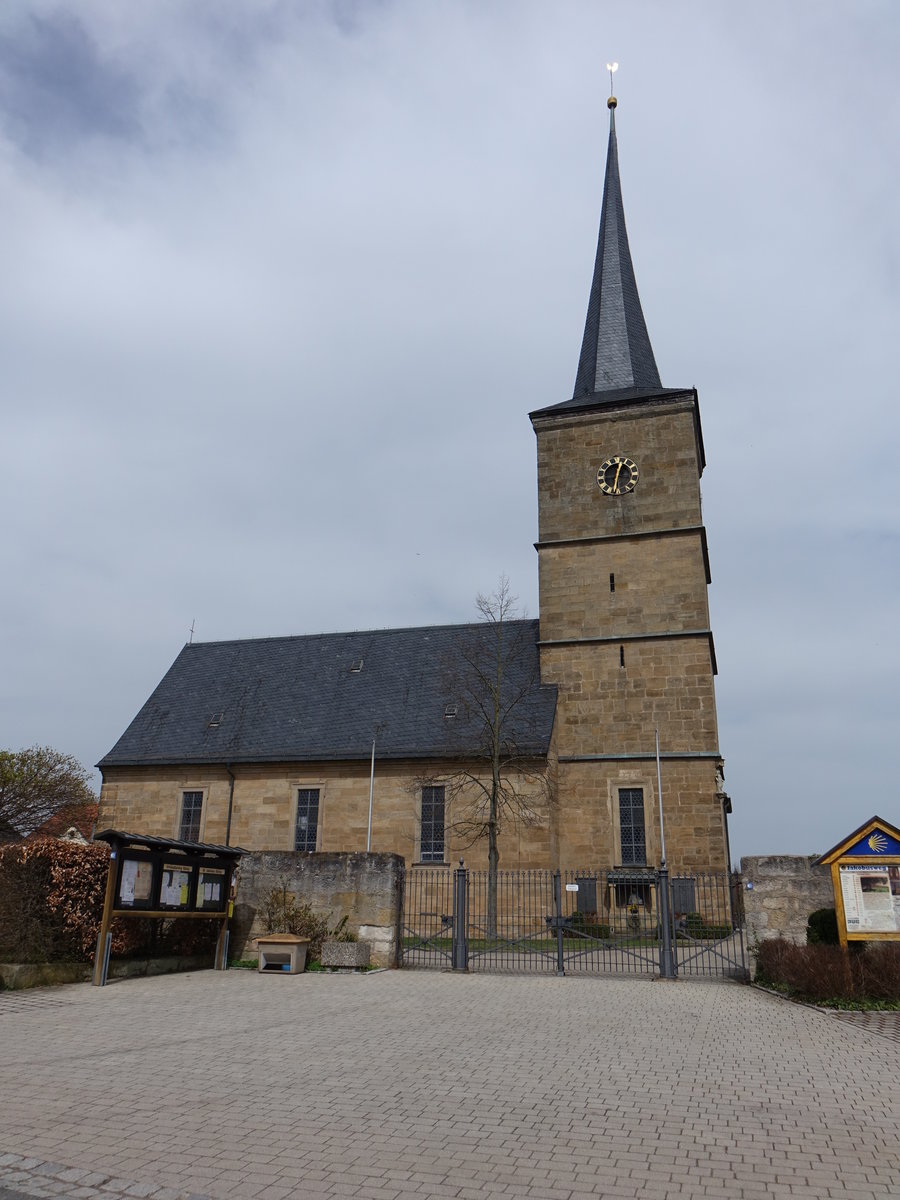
[[0, 0, 900, 858]]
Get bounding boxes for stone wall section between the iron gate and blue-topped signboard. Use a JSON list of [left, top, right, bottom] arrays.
[[740, 854, 834, 946]]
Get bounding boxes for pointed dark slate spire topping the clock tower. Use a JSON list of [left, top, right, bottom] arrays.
[[574, 96, 661, 400]]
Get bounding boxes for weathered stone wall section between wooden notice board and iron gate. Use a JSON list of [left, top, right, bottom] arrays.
[[228, 851, 403, 967]]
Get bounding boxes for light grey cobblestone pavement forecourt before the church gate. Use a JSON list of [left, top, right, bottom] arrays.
[[0, 971, 900, 1200]]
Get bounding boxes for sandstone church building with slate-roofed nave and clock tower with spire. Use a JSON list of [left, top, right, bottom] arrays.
[[98, 97, 730, 871]]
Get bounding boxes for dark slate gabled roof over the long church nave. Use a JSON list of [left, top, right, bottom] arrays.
[[97, 620, 557, 768]]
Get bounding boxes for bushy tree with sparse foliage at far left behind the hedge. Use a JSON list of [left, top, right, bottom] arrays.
[[0, 746, 97, 838]]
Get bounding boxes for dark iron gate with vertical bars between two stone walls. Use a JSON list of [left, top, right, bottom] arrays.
[[401, 863, 749, 979]]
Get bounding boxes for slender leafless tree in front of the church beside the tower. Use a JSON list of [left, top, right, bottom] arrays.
[[440, 576, 552, 938]]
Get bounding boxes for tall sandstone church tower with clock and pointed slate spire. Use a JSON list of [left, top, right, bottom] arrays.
[[530, 97, 730, 871]]
